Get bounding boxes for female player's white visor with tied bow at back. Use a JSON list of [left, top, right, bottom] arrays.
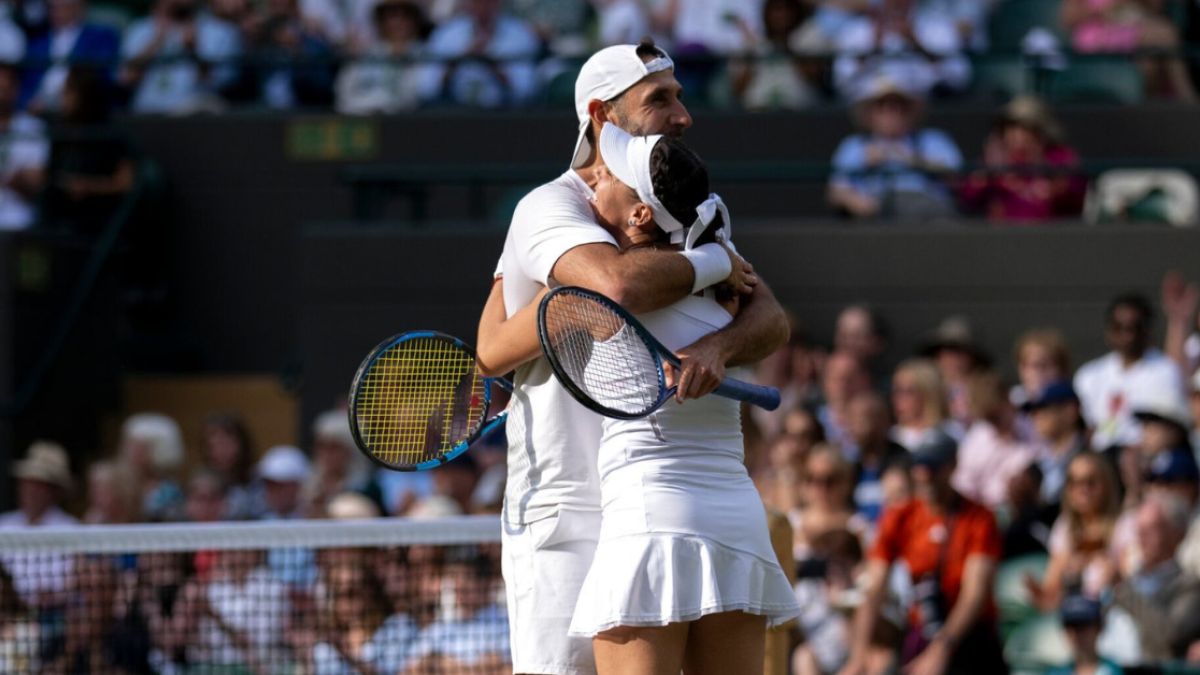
[[600, 123, 730, 250]]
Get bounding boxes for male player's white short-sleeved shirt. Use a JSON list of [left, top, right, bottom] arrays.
[[500, 171, 617, 524]]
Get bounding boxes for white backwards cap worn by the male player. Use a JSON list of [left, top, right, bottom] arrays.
[[571, 44, 674, 168]]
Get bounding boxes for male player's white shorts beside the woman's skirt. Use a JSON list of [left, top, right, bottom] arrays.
[[502, 509, 600, 675]]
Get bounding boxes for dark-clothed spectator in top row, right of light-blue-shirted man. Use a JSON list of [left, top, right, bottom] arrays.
[[239, 0, 334, 110]]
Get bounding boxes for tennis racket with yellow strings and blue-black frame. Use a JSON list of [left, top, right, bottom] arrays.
[[349, 330, 512, 471]]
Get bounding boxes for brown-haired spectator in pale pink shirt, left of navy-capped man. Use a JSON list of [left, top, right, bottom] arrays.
[[953, 371, 1036, 512]]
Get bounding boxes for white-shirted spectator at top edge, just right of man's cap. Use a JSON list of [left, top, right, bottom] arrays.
[[673, 0, 763, 54]]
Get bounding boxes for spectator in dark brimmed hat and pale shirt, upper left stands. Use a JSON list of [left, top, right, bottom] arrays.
[[334, 0, 432, 115]]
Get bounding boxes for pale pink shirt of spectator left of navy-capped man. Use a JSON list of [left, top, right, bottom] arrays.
[[950, 420, 1037, 510]]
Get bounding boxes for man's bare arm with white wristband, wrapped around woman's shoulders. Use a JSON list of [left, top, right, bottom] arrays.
[[551, 243, 758, 313]]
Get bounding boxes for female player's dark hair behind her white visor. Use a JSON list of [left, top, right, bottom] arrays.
[[650, 137, 725, 244]]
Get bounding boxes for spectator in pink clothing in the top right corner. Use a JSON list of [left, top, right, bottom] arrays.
[[1060, 0, 1196, 101]]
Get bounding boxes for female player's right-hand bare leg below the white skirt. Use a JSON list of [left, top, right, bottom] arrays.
[[683, 611, 767, 675]]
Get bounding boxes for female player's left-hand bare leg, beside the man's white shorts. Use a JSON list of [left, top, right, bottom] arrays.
[[592, 623, 691, 675]]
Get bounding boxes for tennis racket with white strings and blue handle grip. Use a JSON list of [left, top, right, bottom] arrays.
[[538, 286, 779, 419]]
